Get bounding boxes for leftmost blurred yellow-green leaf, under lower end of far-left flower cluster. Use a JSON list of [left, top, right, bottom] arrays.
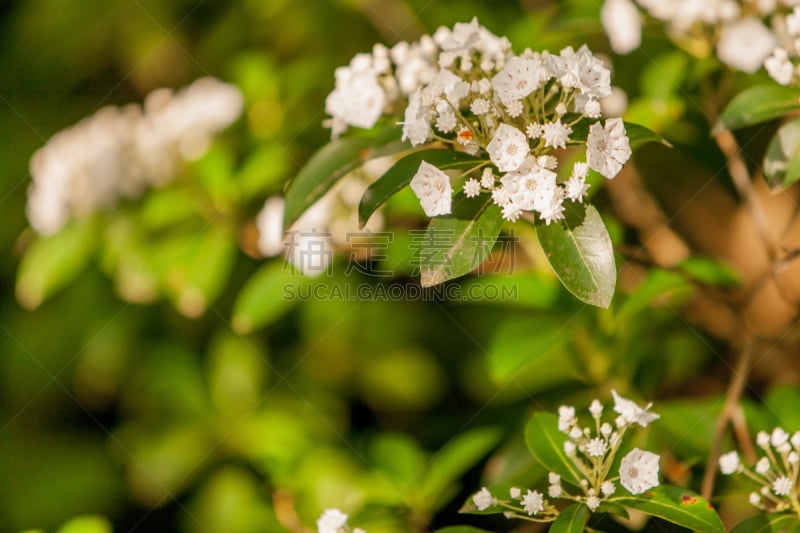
[[16, 219, 97, 309]]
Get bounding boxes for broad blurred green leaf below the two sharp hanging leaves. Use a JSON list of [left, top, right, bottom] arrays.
[[487, 317, 578, 388]]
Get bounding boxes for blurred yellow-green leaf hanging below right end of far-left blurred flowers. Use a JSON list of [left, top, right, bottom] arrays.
[[165, 224, 237, 318]]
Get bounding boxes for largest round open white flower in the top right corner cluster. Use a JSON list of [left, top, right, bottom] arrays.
[[717, 17, 775, 73]]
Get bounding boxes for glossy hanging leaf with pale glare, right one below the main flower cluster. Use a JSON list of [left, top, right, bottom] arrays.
[[536, 202, 617, 307]]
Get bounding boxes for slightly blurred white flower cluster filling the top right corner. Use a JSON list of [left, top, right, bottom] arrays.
[[601, 0, 800, 81]]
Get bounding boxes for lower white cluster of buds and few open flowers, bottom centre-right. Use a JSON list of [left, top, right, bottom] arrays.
[[472, 391, 661, 520]]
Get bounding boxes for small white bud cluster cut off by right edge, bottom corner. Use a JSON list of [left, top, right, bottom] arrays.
[[719, 427, 800, 513]]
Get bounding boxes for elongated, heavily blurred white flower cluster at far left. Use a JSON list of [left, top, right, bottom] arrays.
[[27, 78, 243, 235]]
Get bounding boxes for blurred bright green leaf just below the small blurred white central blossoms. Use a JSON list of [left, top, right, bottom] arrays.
[[232, 260, 312, 334]]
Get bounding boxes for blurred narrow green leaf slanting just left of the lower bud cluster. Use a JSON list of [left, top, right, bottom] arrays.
[[419, 428, 500, 510]]
